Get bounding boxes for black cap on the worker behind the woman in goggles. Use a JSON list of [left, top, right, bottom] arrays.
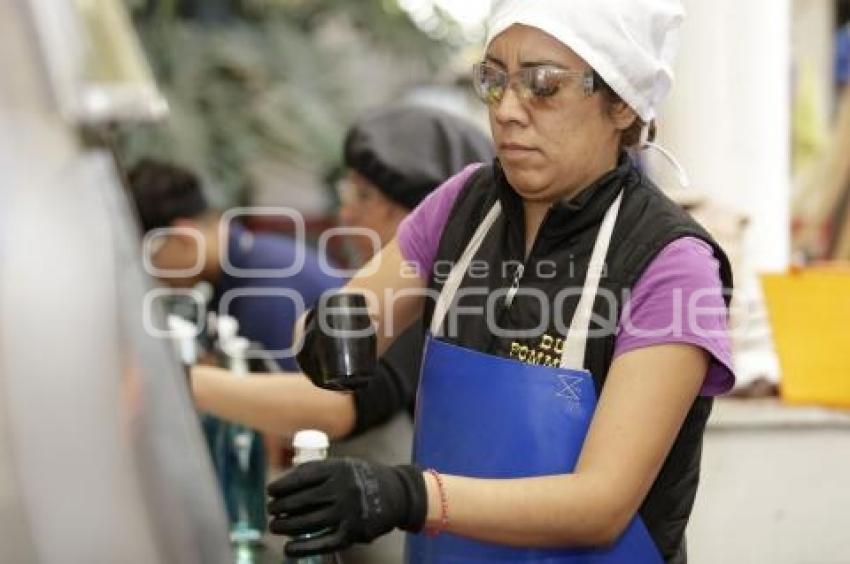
[[345, 106, 494, 209]]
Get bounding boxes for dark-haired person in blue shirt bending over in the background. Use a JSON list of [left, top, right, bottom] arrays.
[[127, 159, 345, 370]]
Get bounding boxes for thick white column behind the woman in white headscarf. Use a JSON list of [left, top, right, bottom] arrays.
[[650, 0, 791, 271]]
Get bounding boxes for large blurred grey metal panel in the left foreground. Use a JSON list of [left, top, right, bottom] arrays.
[[0, 0, 232, 564]]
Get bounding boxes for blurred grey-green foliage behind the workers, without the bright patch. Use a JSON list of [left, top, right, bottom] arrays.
[[119, 0, 450, 205]]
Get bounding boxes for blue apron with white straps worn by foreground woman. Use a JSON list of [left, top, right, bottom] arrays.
[[406, 192, 662, 564]]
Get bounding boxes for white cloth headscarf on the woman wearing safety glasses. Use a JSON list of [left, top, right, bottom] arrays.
[[487, 0, 685, 123]]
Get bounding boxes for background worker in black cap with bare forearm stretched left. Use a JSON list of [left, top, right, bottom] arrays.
[[186, 106, 494, 564]]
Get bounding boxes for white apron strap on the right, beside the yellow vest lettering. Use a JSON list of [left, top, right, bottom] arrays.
[[561, 192, 623, 370]]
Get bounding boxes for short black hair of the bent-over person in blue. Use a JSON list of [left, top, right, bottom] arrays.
[[127, 159, 209, 232]]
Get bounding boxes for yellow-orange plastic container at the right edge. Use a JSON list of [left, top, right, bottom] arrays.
[[762, 267, 850, 408]]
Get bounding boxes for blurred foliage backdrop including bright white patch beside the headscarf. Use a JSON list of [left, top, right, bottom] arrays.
[[120, 0, 489, 214]]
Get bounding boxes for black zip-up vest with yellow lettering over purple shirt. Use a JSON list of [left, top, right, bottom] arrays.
[[424, 157, 732, 563]]
